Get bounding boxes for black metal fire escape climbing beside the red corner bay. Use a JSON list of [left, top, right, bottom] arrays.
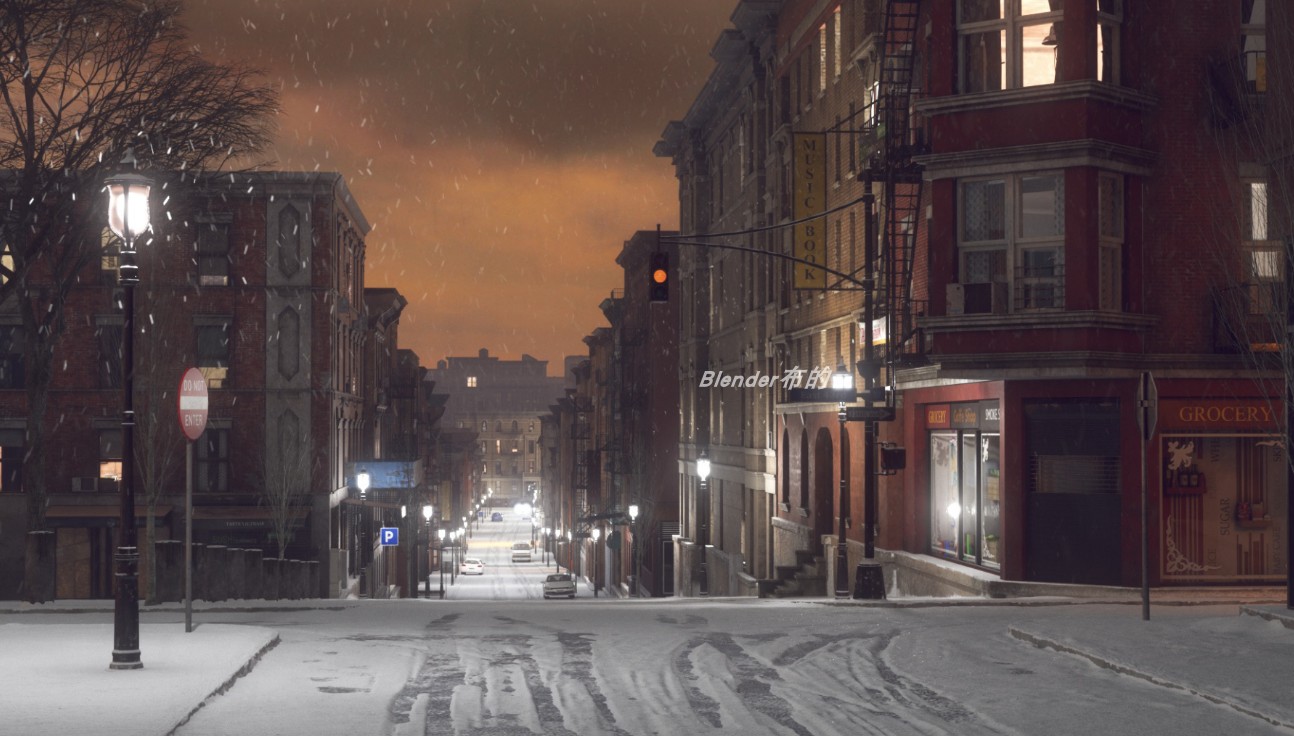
[[870, 0, 924, 365]]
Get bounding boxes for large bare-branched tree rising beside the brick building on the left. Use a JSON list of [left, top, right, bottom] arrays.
[[0, 0, 277, 592]]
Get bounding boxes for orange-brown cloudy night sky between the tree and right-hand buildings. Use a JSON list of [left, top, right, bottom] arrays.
[[185, 0, 736, 373]]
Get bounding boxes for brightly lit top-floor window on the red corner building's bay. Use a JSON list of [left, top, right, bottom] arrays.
[[958, 0, 1064, 92]]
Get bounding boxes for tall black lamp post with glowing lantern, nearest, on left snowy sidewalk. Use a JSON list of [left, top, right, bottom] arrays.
[[105, 157, 153, 670]]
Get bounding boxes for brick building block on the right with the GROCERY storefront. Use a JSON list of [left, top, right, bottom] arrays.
[[655, 0, 1294, 595]]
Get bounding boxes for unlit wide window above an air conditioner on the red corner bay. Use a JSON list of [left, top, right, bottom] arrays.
[[959, 172, 1065, 309]]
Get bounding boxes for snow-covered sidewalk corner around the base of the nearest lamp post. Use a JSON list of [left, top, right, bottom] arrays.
[[0, 617, 278, 736]]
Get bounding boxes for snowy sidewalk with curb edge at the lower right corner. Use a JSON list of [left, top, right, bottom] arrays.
[[1008, 605, 1294, 731]]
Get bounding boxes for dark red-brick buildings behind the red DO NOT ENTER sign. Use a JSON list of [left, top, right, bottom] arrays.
[[0, 171, 436, 600]]
